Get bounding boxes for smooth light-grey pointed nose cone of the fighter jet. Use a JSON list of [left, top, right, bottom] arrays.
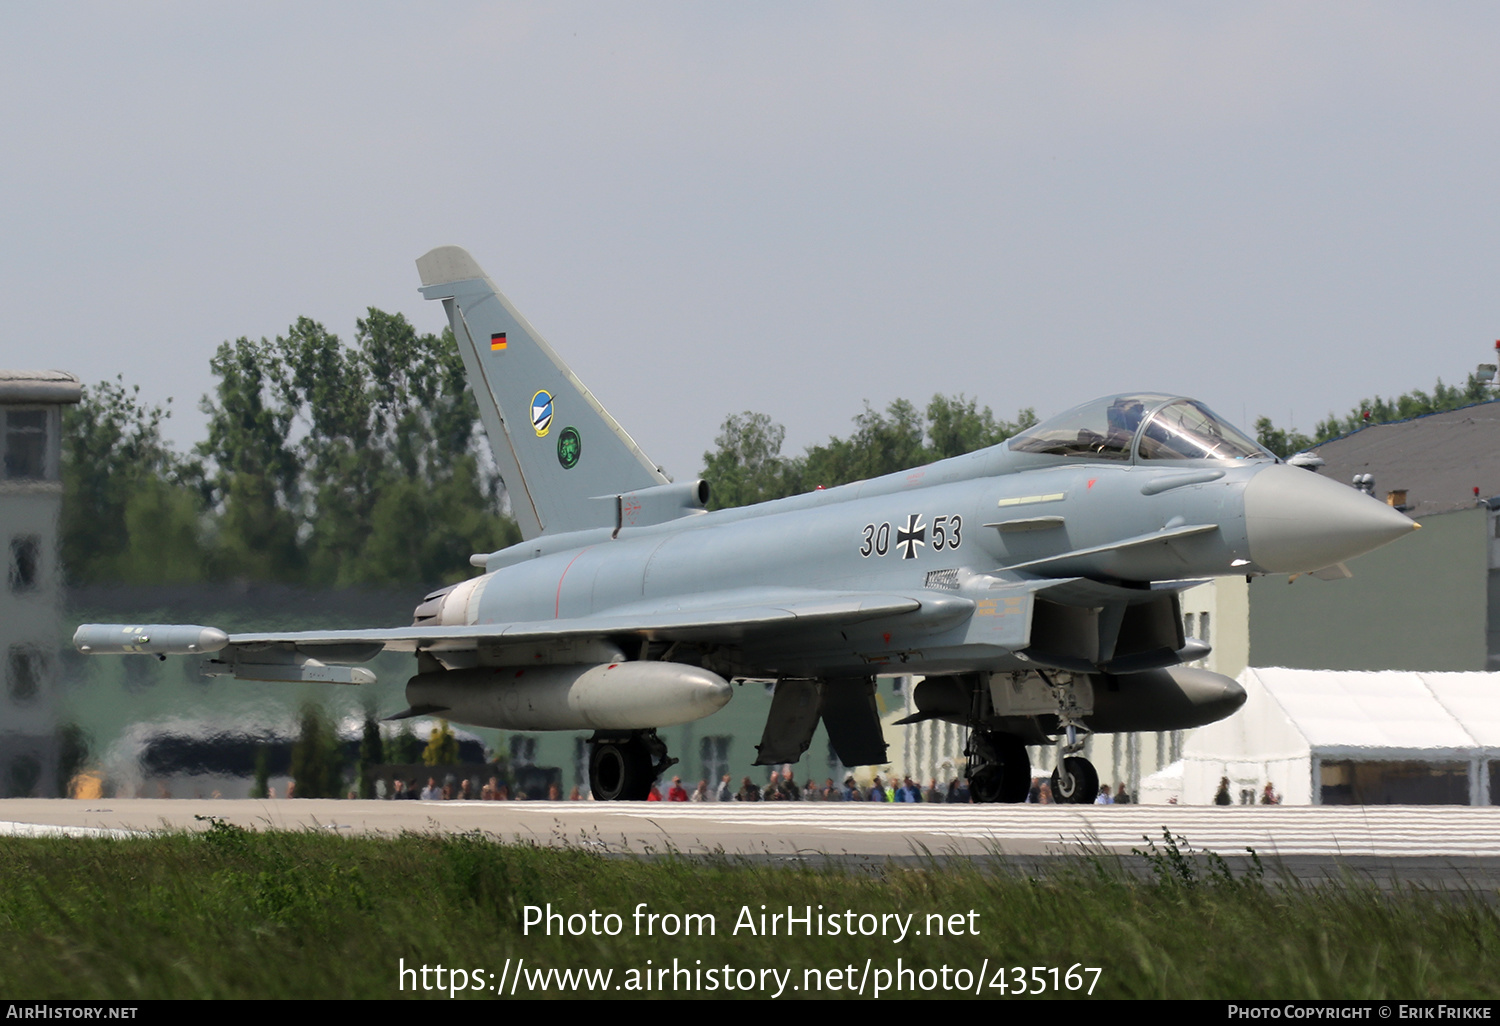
[[1245, 464, 1416, 573]]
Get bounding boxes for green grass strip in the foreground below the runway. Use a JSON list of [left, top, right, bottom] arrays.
[[0, 822, 1500, 999]]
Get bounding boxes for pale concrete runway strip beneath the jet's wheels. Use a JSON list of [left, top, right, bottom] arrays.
[[0, 798, 1500, 887]]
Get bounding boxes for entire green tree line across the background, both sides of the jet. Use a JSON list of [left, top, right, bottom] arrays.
[[62, 308, 1491, 588]]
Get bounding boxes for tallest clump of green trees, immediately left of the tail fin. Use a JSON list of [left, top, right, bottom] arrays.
[[204, 309, 519, 587]]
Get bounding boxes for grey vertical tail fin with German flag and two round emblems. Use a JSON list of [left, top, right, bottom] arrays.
[[417, 246, 668, 539]]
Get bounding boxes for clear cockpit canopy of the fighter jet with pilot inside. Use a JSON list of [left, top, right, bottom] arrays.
[[1008, 392, 1275, 461]]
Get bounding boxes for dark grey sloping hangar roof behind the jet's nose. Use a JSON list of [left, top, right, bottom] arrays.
[[1313, 401, 1500, 516]]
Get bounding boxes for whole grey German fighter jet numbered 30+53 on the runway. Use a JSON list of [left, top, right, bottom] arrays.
[[74, 246, 1415, 803]]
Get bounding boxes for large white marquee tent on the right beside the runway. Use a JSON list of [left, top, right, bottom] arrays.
[[1181, 668, 1500, 806]]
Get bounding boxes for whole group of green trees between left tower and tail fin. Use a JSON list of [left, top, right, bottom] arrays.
[[62, 308, 521, 587]]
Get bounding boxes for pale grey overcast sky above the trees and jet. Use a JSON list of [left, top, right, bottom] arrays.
[[0, 2, 1500, 479]]
